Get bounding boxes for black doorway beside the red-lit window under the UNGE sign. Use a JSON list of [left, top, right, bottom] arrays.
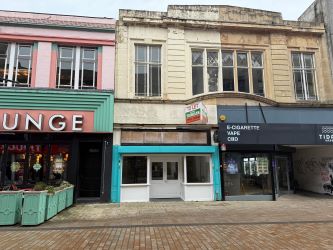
[[79, 142, 102, 198]]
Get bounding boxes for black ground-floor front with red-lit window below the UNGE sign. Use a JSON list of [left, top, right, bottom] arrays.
[[0, 134, 112, 202]]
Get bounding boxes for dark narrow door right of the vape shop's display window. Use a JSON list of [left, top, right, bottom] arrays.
[[275, 156, 293, 196]]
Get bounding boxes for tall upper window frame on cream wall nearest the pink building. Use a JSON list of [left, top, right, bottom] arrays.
[[133, 43, 163, 98]]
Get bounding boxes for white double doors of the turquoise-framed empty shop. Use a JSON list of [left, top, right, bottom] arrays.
[[150, 156, 182, 198]]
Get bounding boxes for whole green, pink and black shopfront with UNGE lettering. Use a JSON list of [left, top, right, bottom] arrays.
[[0, 88, 113, 202]]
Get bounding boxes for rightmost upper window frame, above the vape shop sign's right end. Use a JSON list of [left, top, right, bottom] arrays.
[[291, 51, 319, 101]]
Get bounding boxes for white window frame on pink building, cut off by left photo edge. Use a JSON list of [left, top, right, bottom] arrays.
[[1, 42, 34, 87]]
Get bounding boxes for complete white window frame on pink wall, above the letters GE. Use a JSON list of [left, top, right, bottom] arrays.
[[56, 46, 98, 89]]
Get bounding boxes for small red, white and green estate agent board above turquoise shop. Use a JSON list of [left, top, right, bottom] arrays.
[[185, 102, 208, 124]]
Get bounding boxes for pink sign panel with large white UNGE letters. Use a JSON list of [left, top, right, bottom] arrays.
[[0, 110, 93, 132]]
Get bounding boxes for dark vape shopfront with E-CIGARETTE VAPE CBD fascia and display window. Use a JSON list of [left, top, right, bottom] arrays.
[[218, 106, 333, 200]]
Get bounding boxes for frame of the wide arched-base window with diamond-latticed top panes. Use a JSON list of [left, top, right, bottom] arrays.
[[190, 47, 266, 97]]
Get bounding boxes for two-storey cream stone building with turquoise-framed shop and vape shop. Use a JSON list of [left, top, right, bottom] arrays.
[[112, 5, 333, 202]]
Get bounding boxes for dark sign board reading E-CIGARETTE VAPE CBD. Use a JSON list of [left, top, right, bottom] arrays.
[[219, 123, 333, 145]]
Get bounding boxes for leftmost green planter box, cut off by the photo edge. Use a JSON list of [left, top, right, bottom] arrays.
[[0, 191, 23, 226]]
